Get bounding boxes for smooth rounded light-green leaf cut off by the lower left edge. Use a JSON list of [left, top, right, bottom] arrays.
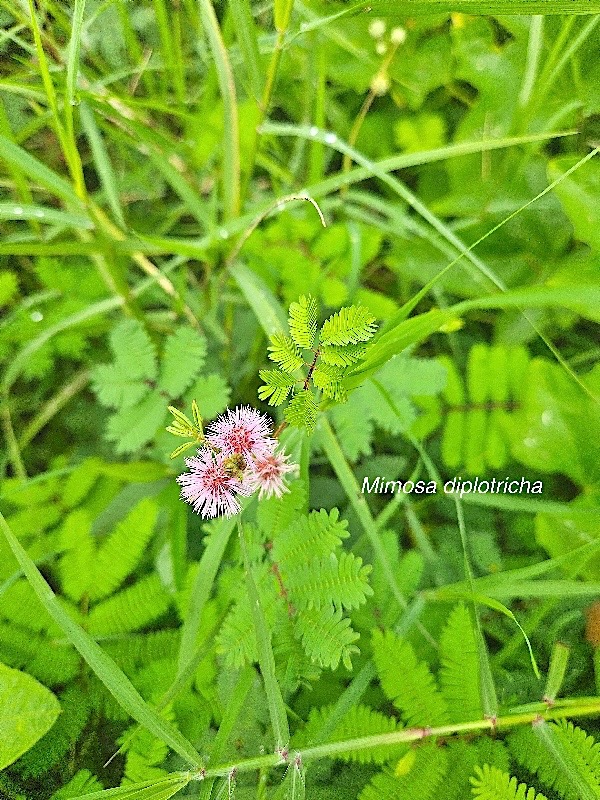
[[0, 663, 60, 770]]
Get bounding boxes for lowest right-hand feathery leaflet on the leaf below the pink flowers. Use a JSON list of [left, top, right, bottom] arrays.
[[295, 606, 360, 670]]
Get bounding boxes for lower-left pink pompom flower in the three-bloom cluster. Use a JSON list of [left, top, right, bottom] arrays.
[[177, 447, 254, 519]]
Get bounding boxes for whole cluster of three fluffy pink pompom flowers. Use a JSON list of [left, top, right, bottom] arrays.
[[177, 406, 296, 518]]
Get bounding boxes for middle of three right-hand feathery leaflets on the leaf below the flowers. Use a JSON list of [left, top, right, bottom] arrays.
[[283, 552, 373, 609]]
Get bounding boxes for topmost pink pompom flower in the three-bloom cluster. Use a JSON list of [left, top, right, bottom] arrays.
[[206, 406, 276, 456]]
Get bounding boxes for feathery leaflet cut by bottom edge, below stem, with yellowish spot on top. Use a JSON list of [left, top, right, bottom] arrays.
[[359, 742, 448, 800]]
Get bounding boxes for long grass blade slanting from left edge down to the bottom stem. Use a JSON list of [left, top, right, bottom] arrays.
[[0, 513, 202, 767]]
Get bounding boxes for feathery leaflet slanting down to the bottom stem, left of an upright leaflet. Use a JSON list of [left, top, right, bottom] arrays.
[[372, 629, 448, 728]]
